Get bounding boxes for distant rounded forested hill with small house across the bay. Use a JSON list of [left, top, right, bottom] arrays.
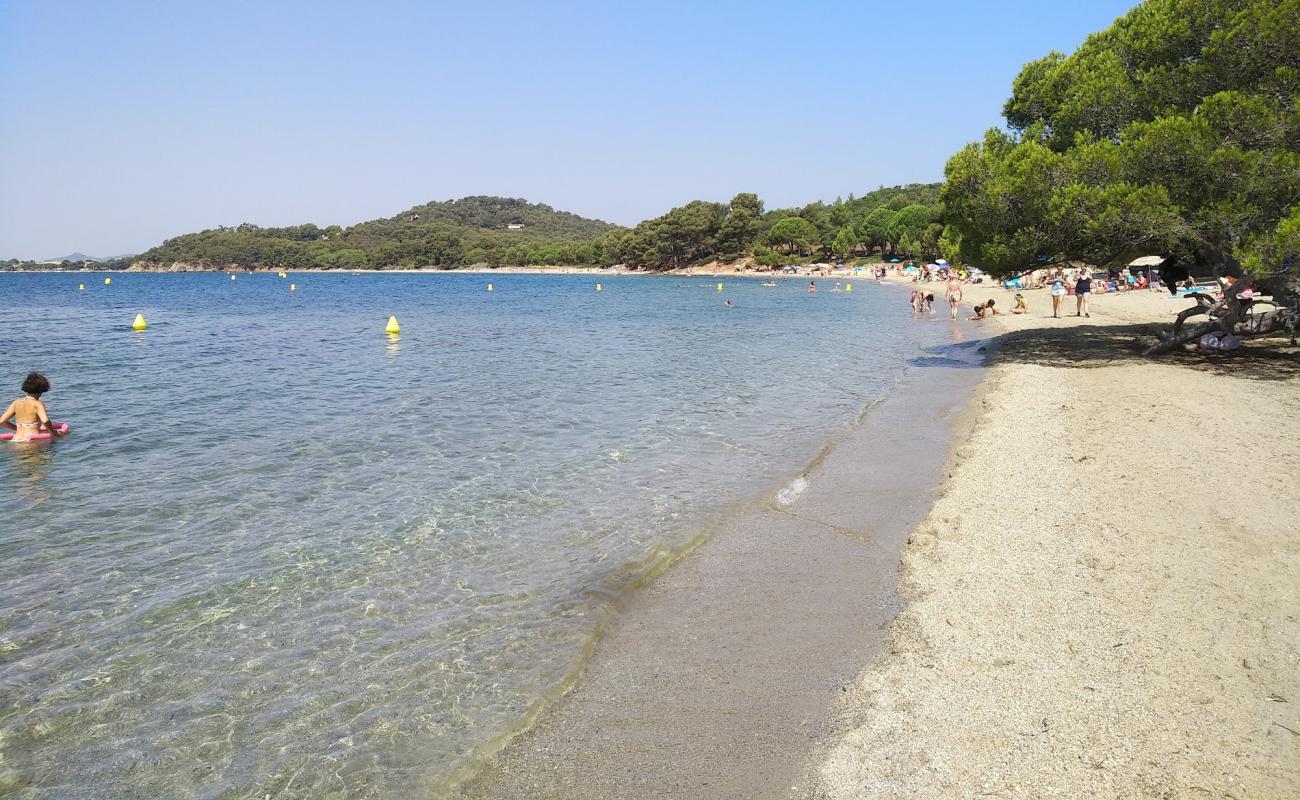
[[137, 196, 619, 269]]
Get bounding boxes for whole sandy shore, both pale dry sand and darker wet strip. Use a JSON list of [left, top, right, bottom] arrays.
[[463, 278, 1300, 800]]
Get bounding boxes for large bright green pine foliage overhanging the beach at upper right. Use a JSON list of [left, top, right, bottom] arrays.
[[941, 0, 1300, 271]]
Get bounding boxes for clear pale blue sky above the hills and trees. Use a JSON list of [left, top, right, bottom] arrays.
[[0, 0, 1134, 259]]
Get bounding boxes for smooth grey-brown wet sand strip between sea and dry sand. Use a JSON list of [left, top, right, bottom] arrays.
[[460, 321, 983, 800]]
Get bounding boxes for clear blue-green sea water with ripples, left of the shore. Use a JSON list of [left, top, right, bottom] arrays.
[[0, 273, 950, 799]]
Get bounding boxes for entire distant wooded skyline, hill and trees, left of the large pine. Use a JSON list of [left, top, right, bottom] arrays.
[[122, 183, 946, 269]]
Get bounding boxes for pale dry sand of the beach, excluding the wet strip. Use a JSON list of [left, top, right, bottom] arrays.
[[805, 278, 1300, 800]]
